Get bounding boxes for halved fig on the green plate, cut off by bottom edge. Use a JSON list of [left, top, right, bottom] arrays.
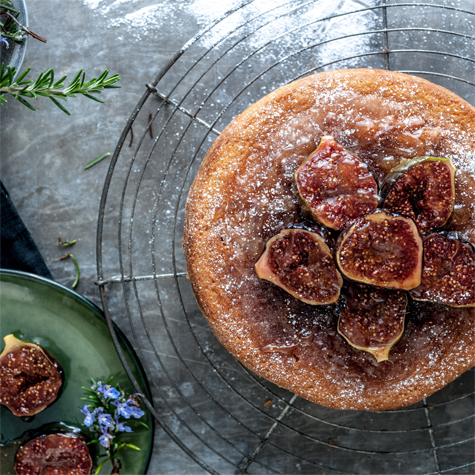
[[15, 433, 92, 475]]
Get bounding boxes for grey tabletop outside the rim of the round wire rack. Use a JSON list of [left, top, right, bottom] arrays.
[[0, 0, 224, 474]]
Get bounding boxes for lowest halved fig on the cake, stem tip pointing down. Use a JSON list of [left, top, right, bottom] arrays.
[[338, 282, 407, 363]]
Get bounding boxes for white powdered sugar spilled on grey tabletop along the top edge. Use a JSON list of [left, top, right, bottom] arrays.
[[82, 0, 380, 54]]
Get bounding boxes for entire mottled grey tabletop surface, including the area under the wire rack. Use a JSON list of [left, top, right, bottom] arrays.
[[0, 0, 475, 475]]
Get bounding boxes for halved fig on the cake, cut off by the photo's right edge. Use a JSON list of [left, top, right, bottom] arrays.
[[410, 233, 475, 307]]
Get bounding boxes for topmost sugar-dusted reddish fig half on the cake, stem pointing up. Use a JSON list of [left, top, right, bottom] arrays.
[[294, 136, 379, 230]]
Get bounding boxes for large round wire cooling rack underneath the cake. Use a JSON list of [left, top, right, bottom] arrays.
[[97, 0, 475, 474]]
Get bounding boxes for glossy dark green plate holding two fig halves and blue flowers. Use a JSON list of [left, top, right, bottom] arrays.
[[0, 270, 153, 475]]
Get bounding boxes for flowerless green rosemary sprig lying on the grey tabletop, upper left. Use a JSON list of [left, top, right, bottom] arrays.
[[0, 63, 120, 115]]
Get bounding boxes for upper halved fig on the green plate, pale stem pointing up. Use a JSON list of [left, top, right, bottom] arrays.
[[0, 335, 63, 417]]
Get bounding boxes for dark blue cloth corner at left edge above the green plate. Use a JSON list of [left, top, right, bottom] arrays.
[[0, 182, 53, 279]]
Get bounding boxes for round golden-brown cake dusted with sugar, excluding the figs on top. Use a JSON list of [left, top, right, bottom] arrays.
[[183, 69, 475, 410]]
